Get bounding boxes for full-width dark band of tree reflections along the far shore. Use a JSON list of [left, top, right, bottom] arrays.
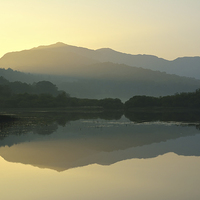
[[0, 111, 200, 140]]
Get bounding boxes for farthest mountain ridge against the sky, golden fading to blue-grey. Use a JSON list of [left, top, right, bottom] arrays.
[[0, 43, 200, 79]]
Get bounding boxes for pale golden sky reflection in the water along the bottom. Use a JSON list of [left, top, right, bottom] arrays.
[[0, 153, 200, 200]]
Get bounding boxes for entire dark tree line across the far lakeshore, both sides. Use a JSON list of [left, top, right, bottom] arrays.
[[0, 77, 200, 110]]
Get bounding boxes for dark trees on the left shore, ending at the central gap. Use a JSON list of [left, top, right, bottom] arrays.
[[0, 77, 123, 109]]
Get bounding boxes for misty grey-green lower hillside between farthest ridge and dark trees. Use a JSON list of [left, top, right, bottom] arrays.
[[0, 62, 200, 101]]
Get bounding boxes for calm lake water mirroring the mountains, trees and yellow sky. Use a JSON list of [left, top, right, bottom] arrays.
[[0, 113, 200, 200]]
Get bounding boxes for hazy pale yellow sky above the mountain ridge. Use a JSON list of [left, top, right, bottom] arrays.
[[0, 0, 200, 59]]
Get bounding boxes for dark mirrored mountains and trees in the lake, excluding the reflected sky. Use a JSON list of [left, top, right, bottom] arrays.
[[0, 112, 200, 171]]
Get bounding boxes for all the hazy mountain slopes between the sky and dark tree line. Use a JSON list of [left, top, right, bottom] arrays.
[[0, 43, 200, 100]]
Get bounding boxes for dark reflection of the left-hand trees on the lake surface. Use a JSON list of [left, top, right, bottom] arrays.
[[0, 112, 122, 139]]
